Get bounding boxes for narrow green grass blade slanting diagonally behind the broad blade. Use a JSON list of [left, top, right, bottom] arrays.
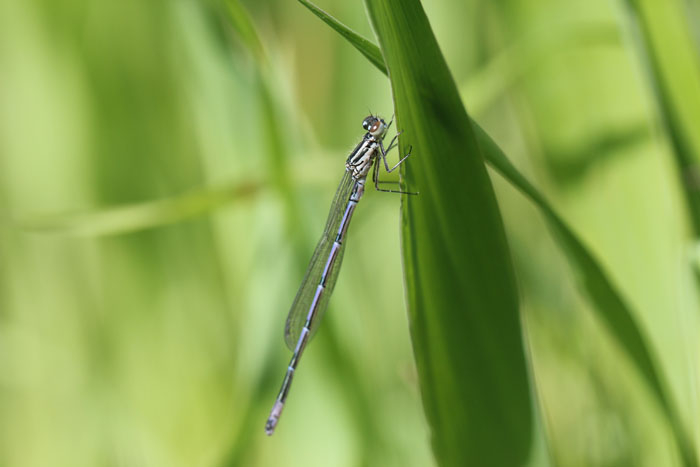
[[300, 0, 695, 465]]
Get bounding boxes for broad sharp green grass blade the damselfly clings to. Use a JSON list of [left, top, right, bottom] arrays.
[[366, 0, 533, 466]]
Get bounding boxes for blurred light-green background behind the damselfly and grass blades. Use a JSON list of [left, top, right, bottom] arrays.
[[0, 0, 700, 466]]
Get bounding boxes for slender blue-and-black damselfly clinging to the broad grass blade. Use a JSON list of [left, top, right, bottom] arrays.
[[265, 115, 415, 435]]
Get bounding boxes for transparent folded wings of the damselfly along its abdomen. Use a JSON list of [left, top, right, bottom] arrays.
[[284, 171, 354, 350]]
